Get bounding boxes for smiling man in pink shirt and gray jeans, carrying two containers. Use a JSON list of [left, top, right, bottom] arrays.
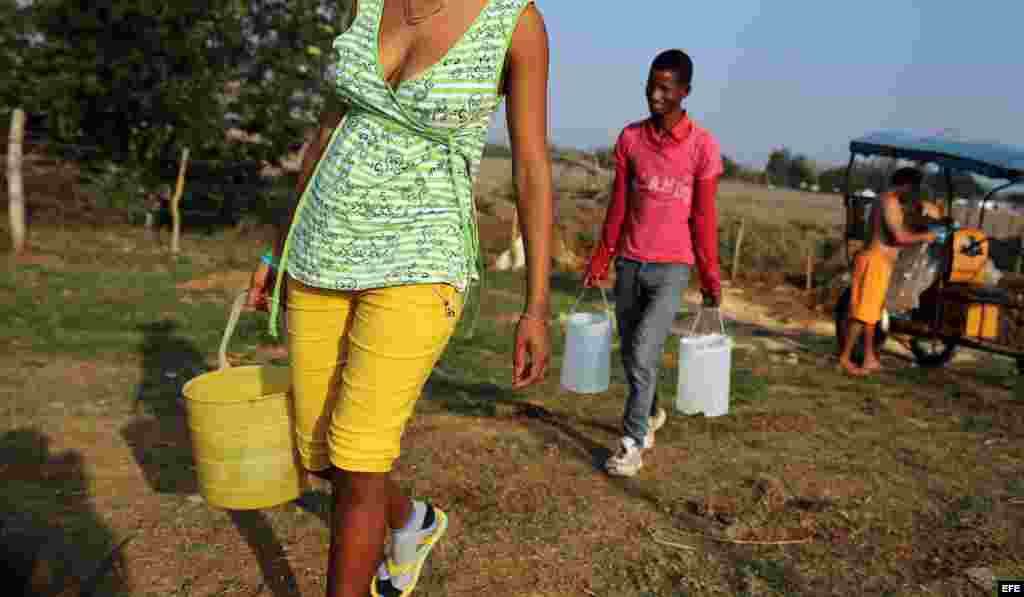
[[584, 50, 723, 476]]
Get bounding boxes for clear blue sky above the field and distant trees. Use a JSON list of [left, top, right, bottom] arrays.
[[493, 0, 1024, 166]]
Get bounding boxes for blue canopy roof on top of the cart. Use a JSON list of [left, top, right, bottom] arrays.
[[850, 130, 1024, 180]]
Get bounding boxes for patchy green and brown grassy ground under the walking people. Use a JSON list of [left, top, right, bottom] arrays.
[[0, 222, 1024, 597]]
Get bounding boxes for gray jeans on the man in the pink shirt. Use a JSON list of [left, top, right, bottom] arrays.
[[615, 257, 690, 445]]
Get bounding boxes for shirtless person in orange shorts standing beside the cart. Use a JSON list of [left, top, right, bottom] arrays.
[[839, 168, 939, 376]]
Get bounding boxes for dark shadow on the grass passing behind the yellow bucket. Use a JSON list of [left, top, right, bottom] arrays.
[[121, 321, 298, 597]]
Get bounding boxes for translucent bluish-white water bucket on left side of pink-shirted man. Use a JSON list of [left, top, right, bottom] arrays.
[[561, 289, 613, 394]]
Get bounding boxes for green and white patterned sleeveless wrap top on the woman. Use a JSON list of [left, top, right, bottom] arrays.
[[270, 0, 532, 336]]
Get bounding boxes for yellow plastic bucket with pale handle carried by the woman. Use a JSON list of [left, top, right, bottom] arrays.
[[182, 293, 306, 510]]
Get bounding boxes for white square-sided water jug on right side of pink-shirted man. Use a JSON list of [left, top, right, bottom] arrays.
[[676, 309, 732, 417]]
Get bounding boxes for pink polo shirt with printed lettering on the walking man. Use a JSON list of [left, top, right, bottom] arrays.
[[605, 117, 723, 264]]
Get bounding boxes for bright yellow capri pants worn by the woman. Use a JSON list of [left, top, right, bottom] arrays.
[[288, 278, 463, 473]]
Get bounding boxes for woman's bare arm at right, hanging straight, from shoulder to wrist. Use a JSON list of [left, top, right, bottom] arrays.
[[505, 5, 554, 321]]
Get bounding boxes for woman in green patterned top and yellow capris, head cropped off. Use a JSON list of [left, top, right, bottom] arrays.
[[250, 0, 553, 597]]
